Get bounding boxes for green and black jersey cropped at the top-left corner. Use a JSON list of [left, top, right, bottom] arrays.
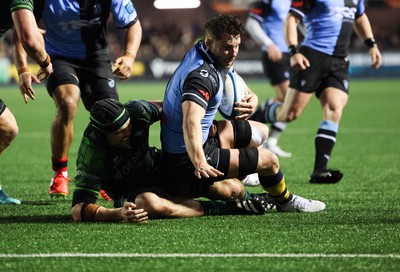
[[0, 0, 33, 38]]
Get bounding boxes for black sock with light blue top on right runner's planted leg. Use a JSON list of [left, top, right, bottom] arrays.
[[314, 120, 339, 171]]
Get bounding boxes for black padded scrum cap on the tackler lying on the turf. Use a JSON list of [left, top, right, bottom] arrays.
[[89, 98, 129, 133]]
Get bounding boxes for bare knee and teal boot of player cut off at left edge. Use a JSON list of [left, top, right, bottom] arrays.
[[0, 103, 21, 205]]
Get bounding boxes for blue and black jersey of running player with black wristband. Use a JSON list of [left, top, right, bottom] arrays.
[[290, 0, 365, 57]]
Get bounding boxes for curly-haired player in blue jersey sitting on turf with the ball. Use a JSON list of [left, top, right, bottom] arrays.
[[161, 15, 325, 212]]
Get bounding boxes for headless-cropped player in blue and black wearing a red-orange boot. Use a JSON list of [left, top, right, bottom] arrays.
[[34, 0, 142, 197]]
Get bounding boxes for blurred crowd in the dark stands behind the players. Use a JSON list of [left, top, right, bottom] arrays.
[[0, 4, 400, 61]]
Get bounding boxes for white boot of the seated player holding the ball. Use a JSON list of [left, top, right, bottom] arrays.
[[276, 195, 325, 212]]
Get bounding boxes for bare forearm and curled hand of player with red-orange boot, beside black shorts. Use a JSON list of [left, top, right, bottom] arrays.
[[113, 20, 142, 80]]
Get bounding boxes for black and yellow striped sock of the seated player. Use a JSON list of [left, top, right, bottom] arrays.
[[258, 169, 293, 204]]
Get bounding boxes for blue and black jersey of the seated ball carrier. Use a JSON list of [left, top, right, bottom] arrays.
[[161, 41, 223, 154]]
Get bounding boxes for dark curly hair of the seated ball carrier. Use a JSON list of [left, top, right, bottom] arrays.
[[204, 14, 246, 39]]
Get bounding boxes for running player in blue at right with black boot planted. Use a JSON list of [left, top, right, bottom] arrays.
[[256, 0, 382, 184]]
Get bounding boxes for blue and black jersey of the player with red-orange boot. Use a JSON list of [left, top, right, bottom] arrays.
[[35, 0, 138, 60]]
